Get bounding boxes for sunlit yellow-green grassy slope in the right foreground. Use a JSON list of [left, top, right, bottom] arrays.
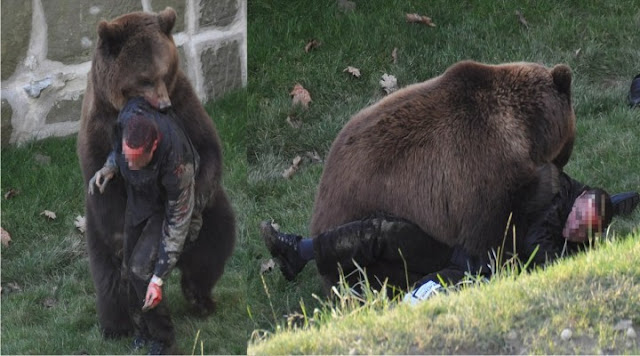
[[249, 233, 640, 354]]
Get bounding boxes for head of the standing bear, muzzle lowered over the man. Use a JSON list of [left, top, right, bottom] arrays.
[[93, 7, 179, 110]]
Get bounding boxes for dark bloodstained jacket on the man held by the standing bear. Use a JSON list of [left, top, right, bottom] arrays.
[[107, 98, 200, 279]]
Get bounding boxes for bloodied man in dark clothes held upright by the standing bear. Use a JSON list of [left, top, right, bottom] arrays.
[[89, 98, 202, 354]]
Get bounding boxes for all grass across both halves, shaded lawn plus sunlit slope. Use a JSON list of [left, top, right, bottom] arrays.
[[0, 0, 640, 354]]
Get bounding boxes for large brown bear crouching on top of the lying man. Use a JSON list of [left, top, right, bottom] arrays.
[[311, 61, 576, 268]]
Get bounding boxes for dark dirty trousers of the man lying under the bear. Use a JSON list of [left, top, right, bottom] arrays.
[[313, 214, 454, 288]]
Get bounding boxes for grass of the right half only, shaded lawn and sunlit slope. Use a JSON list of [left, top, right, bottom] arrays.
[[247, 0, 640, 354]]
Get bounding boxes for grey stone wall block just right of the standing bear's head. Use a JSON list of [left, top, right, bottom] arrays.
[[200, 41, 242, 99]]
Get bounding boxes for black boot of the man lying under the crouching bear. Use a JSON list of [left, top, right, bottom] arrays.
[[260, 221, 307, 281]]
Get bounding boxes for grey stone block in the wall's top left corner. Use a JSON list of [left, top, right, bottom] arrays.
[[0, 0, 32, 80]]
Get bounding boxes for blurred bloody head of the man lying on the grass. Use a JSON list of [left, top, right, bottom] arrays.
[[562, 189, 613, 242]]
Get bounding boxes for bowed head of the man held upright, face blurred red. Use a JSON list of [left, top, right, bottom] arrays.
[[122, 114, 159, 170]]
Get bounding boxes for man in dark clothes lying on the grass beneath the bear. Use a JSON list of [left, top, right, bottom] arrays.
[[261, 165, 640, 303]]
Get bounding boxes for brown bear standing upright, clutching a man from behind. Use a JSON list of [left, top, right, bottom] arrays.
[[77, 8, 235, 337]]
